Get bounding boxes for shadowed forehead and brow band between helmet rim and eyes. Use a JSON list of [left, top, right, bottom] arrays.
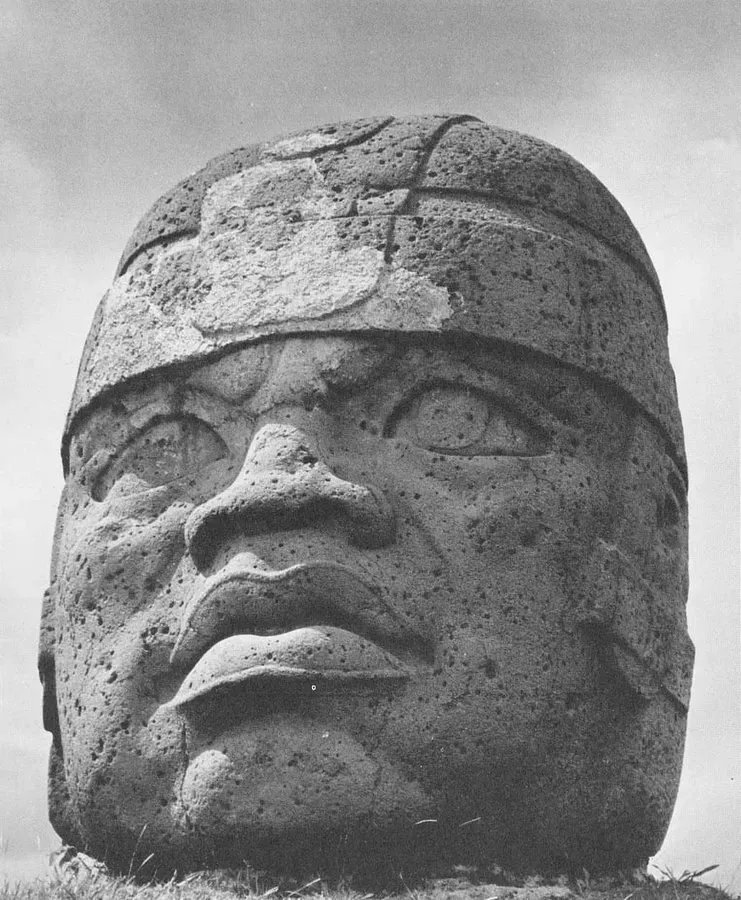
[[65, 335, 648, 478]]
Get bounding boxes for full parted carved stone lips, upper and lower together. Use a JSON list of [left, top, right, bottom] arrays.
[[167, 553, 432, 707]]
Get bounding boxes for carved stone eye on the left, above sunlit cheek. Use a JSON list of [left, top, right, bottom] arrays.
[[91, 415, 228, 500]]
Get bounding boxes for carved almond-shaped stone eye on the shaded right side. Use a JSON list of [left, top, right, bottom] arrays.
[[385, 385, 548, 456]]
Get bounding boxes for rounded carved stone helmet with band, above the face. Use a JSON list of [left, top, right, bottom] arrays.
[[65, 116, 685, 470]]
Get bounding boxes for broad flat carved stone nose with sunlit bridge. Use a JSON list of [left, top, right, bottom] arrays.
[[185, 424, 395, 568]]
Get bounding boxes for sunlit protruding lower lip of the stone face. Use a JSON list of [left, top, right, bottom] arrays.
[[167, 625, 409, 707]]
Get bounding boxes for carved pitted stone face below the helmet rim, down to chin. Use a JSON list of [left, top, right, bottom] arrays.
[[49, 335, 686, 868]]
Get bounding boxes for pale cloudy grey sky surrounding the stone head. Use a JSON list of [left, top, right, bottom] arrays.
[[0, 0, 741, 891]]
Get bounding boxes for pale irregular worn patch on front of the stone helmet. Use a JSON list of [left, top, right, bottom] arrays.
[[194, 160, 451, 342]]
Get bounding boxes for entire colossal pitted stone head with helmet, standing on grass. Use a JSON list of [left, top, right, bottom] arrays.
[[40, 116, 692, 871]]
